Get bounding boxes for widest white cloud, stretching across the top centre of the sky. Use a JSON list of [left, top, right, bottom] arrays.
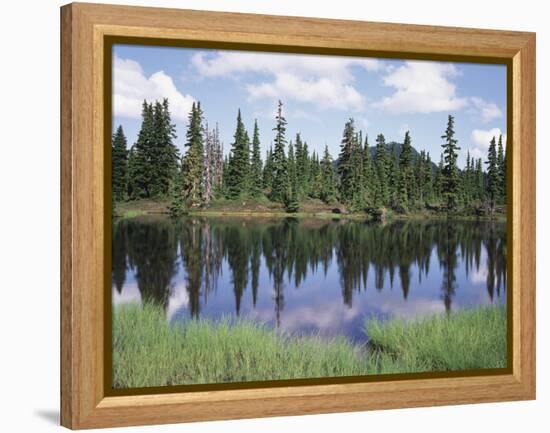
[[192, 52, 382, 111]]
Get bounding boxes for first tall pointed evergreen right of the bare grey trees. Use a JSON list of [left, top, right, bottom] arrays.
[[227, 110, 250, 199]]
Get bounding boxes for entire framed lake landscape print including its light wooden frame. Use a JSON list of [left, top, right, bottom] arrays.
[[61, 4, 535, 429]]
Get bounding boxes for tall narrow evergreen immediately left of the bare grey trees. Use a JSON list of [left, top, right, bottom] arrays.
[[180, 102, 204, 207]]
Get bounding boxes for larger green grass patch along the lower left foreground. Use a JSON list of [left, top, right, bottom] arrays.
[[113, 305, 368, 388]]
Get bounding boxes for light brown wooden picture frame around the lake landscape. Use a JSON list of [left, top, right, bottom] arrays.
[[61, 3, 535, 429]]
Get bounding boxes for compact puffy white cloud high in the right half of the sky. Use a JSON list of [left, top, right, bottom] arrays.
[[380, 61, 468, 114]]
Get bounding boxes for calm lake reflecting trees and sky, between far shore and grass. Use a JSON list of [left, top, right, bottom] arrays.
[[112, 216, 507, 342]]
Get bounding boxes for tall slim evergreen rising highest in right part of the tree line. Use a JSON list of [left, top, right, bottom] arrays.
[[441, 115, 460, 211]]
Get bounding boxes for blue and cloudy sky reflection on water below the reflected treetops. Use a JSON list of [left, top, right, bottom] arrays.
[[112, 218, 506, 341]]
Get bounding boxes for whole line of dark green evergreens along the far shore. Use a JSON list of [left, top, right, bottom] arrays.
[[112, 99, 506, 216]]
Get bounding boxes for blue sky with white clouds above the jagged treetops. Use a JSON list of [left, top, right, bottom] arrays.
[[112, 45, 506, 167]]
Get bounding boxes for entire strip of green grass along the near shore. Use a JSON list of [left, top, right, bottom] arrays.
[[113, 304, 506, 388]]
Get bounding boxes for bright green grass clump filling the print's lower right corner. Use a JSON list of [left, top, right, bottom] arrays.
[[365, 306, 507, 374]]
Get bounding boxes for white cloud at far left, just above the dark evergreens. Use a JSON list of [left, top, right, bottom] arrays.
[[113, 57, 194, 121]]
